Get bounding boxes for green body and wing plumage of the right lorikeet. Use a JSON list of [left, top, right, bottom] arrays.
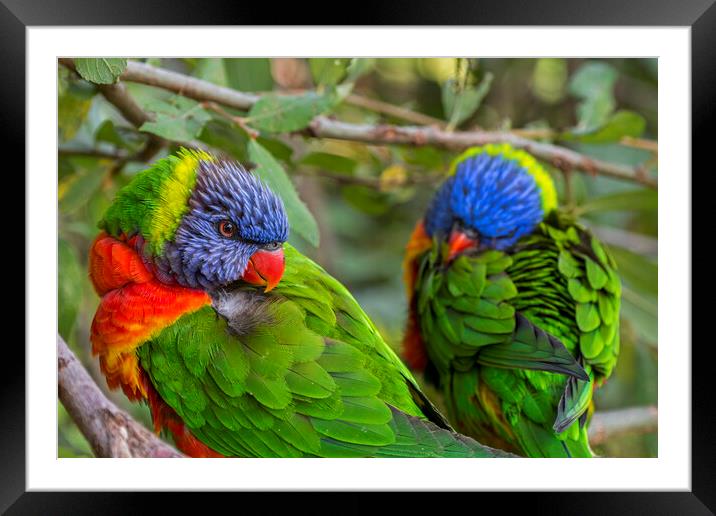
[[414, 211, 621, 457]]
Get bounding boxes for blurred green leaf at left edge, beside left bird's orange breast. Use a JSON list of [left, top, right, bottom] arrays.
[[57, 238, 84, 340]]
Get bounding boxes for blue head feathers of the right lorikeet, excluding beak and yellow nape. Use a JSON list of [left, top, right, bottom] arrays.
[[425, 153, 544, 250]]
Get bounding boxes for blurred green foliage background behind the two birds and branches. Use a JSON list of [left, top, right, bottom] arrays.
[[58, 58, 658, 457]]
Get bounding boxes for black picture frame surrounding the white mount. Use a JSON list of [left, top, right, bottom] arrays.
[[5, 0, 716, 515]]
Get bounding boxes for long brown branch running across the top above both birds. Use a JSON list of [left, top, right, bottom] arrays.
[[65, 59, 657, 188]]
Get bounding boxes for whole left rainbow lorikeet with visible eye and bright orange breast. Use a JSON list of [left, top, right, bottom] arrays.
[[90, 151, 508, 457]]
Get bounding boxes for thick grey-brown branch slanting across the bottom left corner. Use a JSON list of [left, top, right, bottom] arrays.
[[57, 335, 182, 457]]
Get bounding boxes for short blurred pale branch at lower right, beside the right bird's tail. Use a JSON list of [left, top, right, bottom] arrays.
[[589, 405, 659, 444]]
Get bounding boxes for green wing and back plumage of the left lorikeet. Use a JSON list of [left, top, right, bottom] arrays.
[[138, 245, 506, 457]]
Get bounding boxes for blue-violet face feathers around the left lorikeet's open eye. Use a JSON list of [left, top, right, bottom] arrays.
[[155, 161, 288, 290]]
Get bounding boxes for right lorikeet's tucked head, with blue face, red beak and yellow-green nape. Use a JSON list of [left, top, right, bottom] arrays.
[[424, 145, 556, 258]]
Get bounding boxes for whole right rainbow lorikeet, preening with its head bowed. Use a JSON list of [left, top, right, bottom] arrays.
[[404, 144, 621, 457]]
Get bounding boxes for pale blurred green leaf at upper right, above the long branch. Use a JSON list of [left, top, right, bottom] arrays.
[[569, 61, 617, 131]]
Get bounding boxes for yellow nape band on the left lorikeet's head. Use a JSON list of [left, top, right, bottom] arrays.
[[149, 148, 215, 253]]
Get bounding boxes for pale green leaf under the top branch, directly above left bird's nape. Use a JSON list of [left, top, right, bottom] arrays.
[[139, 96, 211, 142]]
